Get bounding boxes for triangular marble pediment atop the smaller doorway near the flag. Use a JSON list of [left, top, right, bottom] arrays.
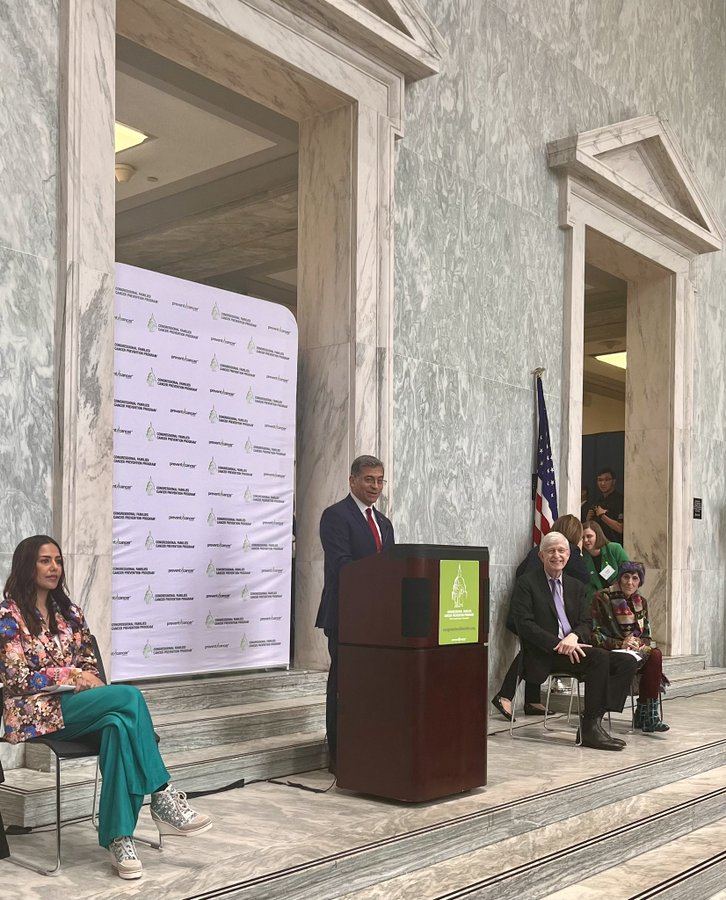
[[547, 116, 724, 253]]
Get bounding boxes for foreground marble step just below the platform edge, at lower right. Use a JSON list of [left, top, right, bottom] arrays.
[[336, 766, 726, 900]]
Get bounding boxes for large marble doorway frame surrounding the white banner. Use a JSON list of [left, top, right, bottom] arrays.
[[55, 0, 442, 667]]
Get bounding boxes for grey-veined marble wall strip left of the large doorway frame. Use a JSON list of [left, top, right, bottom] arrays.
[[0, 0, 58, 564]]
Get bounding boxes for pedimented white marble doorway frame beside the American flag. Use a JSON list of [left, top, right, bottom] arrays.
[[548, 116, 723, 654]]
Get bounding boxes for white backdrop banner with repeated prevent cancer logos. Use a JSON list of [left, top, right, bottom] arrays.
[[112, 264, 297, 680]]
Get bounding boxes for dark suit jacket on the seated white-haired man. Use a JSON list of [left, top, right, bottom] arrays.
[[511, 567, 592, 684]]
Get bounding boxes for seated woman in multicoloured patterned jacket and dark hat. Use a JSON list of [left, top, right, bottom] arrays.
[[592, 561, 670, 732]]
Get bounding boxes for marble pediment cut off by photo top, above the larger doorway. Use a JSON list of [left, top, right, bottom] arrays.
[[279, 0, 445, 81]]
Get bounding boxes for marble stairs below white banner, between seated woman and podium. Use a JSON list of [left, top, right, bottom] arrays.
[[0, 669, 327, 827]]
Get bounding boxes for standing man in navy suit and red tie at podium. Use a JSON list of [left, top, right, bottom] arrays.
[[315, 456, 394, 772]]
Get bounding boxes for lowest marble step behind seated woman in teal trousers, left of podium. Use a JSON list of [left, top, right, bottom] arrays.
[[0, 731, 327, 827]]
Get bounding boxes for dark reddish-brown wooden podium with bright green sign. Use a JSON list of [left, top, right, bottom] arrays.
[[337, 544, 489, 802]]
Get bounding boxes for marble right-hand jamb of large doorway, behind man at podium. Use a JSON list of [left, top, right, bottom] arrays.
[[295, 104, 393, 667]]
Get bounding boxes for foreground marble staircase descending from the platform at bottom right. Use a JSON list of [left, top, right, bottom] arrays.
[[200, 740, 726, 900]]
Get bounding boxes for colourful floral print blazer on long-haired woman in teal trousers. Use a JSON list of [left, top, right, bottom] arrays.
[[0, 600, 98, 744]]
